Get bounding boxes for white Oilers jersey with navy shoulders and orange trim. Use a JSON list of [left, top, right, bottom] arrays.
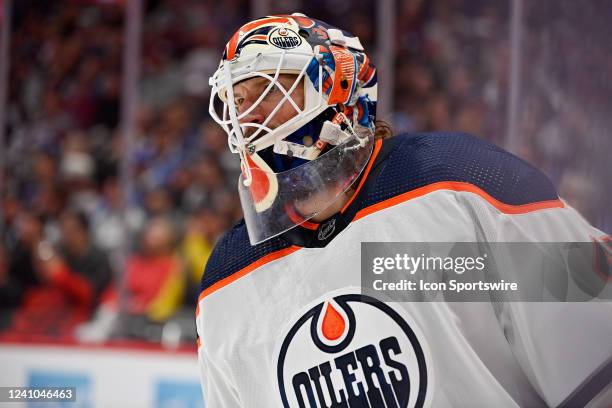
[[196, 133, 612, 408]]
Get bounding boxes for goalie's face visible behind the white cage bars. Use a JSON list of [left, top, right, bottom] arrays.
[[234, 74, 304, 137]]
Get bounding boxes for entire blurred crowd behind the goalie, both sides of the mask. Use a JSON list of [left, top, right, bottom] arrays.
[[0, 0, 612, 344]]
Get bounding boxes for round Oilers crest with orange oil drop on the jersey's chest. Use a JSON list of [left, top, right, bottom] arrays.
[[276, 294, 432, 408]]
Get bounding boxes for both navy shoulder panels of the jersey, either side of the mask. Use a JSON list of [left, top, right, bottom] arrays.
[[200, 133, 558, 292]]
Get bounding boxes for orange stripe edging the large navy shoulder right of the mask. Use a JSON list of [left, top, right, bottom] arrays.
[[353, 181, 565, 221]]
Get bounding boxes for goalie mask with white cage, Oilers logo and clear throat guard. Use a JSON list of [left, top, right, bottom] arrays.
[[209, 14, 376, 244]]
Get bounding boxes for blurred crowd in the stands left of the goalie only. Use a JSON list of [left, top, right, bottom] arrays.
[[0, 1, 248, 343]]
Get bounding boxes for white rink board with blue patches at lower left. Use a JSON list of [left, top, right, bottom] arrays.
[[0, 345, 203, 408]]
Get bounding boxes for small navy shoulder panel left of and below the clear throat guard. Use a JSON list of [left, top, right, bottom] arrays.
[[200, 220, 290, 292]]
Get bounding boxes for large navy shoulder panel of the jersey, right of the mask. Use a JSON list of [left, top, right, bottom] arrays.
[[361, 133, 558, 208]]
